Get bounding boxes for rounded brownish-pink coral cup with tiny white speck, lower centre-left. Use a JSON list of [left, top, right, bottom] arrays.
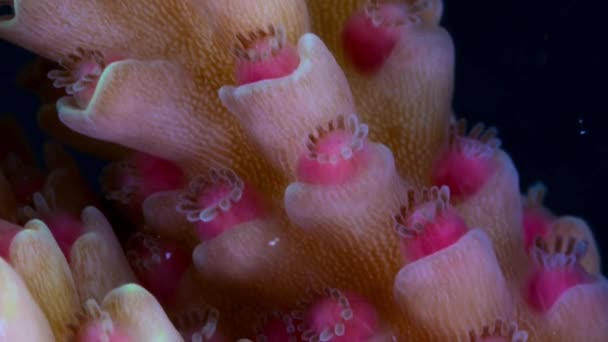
[[193, 219, 318, 310]]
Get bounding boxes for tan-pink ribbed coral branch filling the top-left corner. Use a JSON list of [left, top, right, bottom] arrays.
[[0, 0, 207, 61]]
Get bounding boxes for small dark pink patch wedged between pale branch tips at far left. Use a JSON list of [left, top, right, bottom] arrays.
[[41, 211, 84, 260]]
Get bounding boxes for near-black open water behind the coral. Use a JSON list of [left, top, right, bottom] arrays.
[[0, 0, 608, 260]]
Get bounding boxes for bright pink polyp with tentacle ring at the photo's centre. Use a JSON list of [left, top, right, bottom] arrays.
[[297, 131, 370, 185]]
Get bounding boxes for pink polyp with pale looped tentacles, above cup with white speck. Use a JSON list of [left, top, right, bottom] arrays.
[[197, 183, 264, 241]]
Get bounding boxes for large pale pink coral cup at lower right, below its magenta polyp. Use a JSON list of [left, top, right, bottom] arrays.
[[394, 229, 515, 341]]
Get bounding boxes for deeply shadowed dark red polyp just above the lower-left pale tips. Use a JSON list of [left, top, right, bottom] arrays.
[[126, 233, 192, 305]]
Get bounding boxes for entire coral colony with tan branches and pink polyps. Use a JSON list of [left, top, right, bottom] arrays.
[[0, 0, 608, 342]]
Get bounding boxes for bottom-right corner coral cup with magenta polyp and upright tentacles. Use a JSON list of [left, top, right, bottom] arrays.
[[524, 241, 608, 342]]
